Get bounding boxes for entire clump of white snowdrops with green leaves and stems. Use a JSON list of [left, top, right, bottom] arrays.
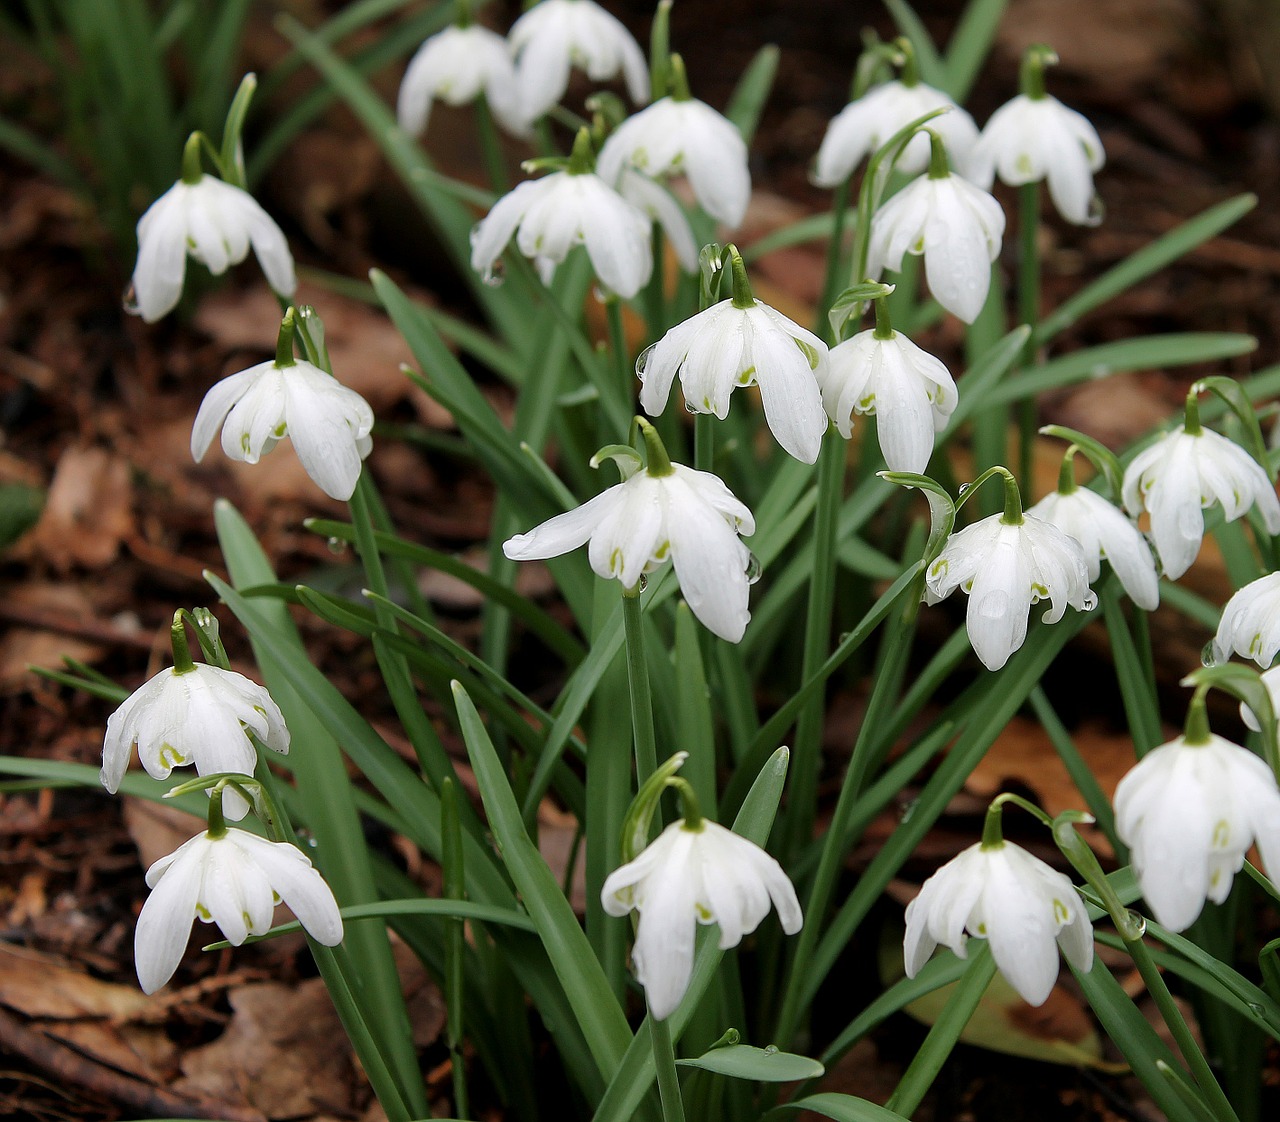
[[32, 10, 1280, 1122]]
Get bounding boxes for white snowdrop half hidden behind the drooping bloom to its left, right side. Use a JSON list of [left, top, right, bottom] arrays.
[[1027, 487, 1160, 612]]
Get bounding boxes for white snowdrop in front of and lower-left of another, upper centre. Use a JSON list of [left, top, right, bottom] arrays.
[[471, 127, 653, 298]]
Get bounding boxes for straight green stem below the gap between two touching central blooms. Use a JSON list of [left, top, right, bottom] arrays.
[[782, 432, 845, 864]]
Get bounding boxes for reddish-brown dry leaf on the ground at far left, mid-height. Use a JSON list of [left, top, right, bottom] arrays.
[[26, 445, 133, 572]]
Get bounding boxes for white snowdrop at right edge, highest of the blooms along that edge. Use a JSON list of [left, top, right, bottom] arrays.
[[1121, 419, 1280, 581]]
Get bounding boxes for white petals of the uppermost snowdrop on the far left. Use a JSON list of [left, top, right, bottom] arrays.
[[132, 174, 297, 324]]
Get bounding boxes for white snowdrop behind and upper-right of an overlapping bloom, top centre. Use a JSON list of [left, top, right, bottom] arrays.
[[599, 55, 751, 226]]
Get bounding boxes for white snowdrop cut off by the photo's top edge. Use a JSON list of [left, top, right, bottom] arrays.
[[507, 0, 649, 123]]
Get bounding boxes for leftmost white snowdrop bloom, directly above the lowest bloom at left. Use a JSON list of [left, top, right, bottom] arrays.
[[100, 663, 289, 819]]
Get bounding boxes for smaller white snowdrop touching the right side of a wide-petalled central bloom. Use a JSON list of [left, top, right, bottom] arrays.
[[822, 285, 960, 472]]
